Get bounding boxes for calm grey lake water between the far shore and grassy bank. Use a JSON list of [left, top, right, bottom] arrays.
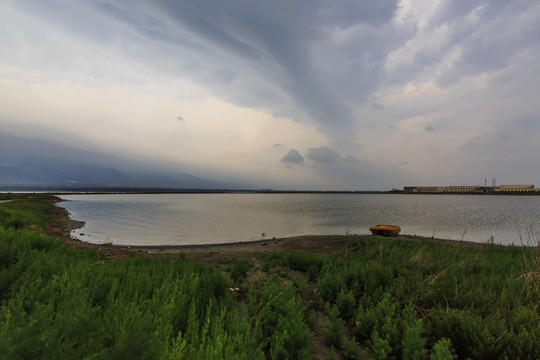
[[56, 194, 540, 245]]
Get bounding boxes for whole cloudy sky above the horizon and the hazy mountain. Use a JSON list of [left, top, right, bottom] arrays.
[[0, 0, 540, 190]]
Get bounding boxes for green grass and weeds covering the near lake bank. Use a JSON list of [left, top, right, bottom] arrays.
[[0, 194, 540, 359]]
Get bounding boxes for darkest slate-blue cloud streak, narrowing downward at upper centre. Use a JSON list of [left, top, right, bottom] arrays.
[[146, 0, 397, 138]]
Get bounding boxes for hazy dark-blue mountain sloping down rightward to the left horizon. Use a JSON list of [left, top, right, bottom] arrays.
[[0, 131, 250, 189]]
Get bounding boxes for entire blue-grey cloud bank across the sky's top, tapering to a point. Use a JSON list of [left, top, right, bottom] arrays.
[[12, 0, 540, 133]]
